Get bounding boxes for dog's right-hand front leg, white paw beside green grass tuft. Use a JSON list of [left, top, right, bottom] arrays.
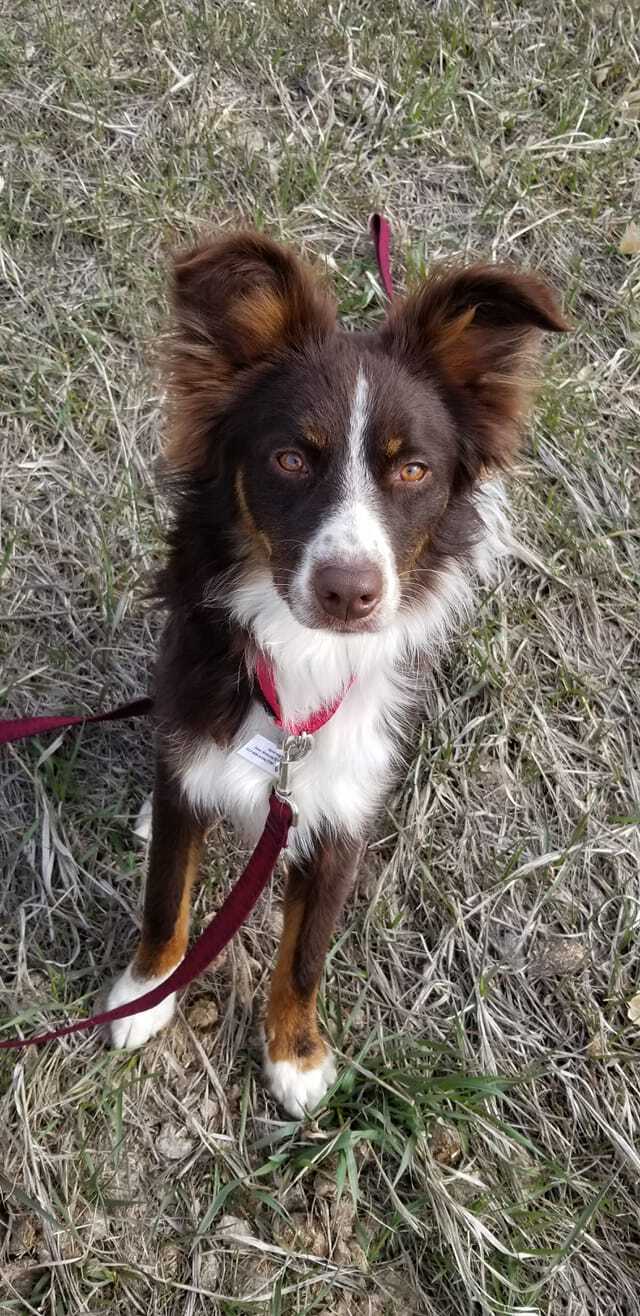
[[265, 841, 362, 1117]]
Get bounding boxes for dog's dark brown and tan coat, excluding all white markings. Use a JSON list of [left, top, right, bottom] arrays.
[[137, 232, 566, 1089]]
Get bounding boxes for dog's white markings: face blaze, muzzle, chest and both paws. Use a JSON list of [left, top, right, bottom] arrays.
[[123, 457, 510, 1119]]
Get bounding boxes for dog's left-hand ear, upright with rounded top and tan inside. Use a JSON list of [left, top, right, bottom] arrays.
[[166, 232, 336, 471]]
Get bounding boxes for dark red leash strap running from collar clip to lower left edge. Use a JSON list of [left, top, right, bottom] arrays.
[[0, 791, 292, 1050]]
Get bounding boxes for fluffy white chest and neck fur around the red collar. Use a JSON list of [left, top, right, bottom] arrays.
[[179, 539, 471, 855]]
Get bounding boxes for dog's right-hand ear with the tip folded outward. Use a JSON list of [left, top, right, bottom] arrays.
[[382, 265, 569, 479]]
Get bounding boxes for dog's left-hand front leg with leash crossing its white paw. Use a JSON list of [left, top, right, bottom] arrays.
[[107, 754, 205, 1049]]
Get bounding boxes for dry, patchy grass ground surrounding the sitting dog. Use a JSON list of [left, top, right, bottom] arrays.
[[0, 0, 640, 1316]]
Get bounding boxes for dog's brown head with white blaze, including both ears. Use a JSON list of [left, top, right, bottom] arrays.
[[167, 233, 566, 634]]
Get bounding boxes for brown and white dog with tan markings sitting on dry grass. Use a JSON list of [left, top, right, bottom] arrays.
[[108, 232, 566, 1116]]
